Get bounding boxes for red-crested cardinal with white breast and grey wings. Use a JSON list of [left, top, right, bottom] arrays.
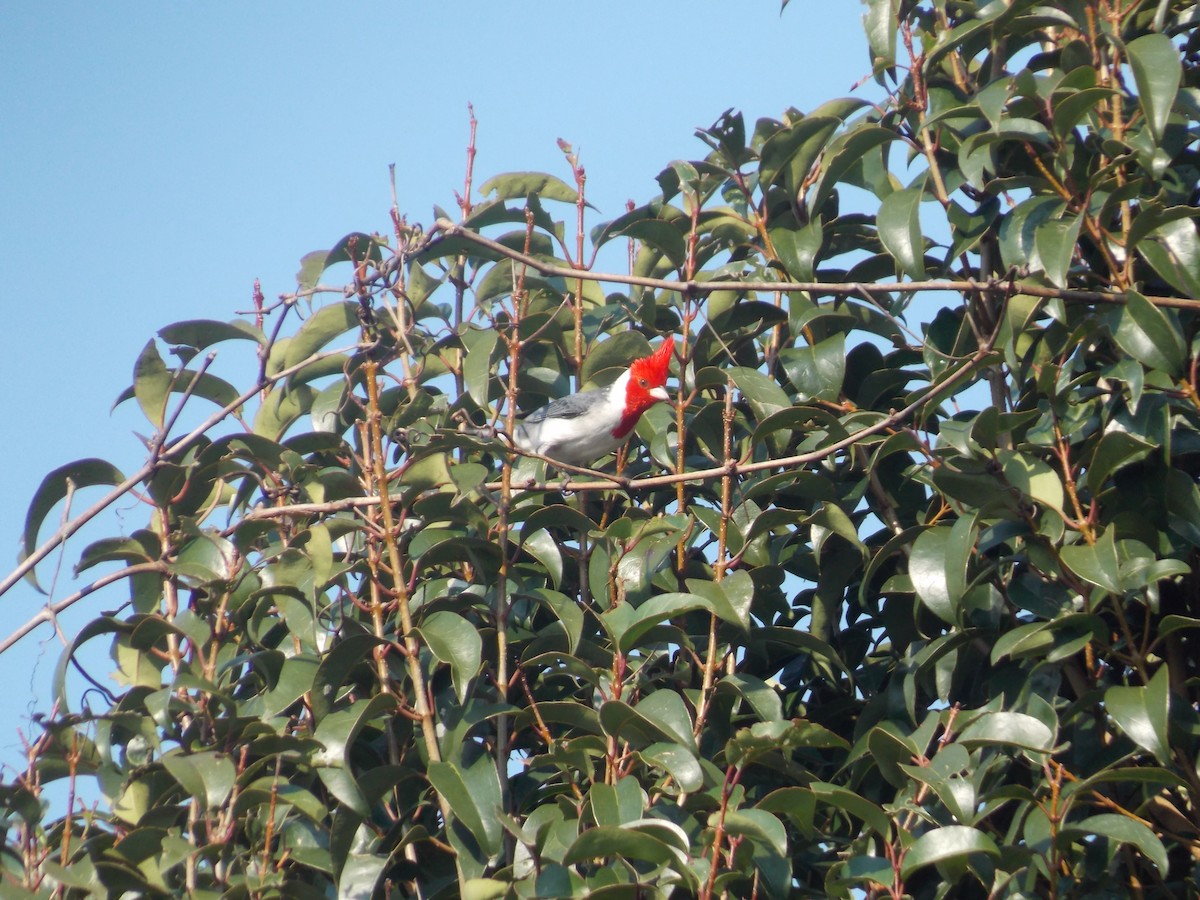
[[512, 340, 674, 466]]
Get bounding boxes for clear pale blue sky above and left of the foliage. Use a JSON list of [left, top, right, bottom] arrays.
[[0, 0, 872, 775]]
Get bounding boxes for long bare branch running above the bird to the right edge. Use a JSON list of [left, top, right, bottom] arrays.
[[428, 218, 1200, 310]]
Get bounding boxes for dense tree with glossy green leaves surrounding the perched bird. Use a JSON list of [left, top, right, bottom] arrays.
[[0, 0, 1200, 898]]
